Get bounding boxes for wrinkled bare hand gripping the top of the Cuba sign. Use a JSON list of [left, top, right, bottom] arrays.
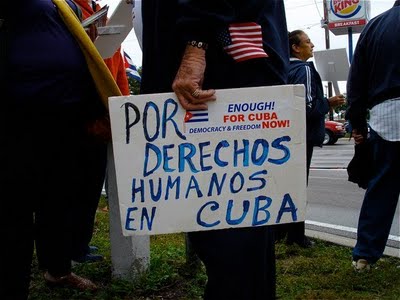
[[172, 46, 216, 110]]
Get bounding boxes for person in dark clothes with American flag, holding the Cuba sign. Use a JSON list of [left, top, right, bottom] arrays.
[[141, 0, 289, 300]]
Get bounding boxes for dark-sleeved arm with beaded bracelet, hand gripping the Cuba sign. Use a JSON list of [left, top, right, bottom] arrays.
[[172, 0, 239, 110]]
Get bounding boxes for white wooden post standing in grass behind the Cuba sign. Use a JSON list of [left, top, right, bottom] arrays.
[[107, 144, 150, 280]]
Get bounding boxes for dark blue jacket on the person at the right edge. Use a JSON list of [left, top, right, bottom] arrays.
[[346, 2, 400, 130]]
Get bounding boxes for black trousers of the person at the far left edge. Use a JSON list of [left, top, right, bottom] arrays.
[[0, 104, 90, 299]]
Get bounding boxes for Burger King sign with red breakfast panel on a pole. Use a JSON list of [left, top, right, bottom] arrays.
[[325, 0, 370, 35]]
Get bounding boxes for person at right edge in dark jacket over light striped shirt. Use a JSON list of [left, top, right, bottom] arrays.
[[346, 1, 400, 271]]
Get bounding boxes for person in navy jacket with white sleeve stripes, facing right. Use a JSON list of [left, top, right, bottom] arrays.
[[281, 30, 345, 247]]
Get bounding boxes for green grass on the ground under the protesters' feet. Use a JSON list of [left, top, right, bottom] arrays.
[[30, 196, 400, 300]]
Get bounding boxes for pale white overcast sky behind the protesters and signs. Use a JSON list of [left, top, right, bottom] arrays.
[[99, 0, 394, 66]]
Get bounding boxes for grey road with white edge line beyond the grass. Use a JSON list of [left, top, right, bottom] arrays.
[[306, 138, 400, 257]]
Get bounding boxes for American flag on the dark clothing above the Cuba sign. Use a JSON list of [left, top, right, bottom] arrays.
[[219, 22, 268, 62]]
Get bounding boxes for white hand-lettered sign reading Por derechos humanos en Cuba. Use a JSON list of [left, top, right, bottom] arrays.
[[109, 85, 306, 235]]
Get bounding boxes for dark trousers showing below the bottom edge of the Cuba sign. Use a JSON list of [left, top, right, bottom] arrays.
[[189, 227, 276, 300]]
